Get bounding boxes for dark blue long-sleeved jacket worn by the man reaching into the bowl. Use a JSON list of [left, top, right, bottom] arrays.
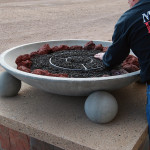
[[103, 0, 150, 82]]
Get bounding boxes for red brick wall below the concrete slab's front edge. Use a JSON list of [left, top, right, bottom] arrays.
[[0, 125, 62, 150]]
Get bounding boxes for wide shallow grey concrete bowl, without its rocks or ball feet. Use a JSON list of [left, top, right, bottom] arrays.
[[0, 40, 140, 96]]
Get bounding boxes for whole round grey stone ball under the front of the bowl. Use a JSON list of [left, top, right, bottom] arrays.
[[84, 91, 118, 123]]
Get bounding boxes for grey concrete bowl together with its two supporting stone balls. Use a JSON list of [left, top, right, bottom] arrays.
[[0, 40, 140, 123]]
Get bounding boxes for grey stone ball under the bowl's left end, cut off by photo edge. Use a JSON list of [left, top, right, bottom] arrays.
[[0, 72, 21, 97]]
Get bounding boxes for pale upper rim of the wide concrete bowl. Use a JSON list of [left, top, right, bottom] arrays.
[[0, 39, 140, 82]]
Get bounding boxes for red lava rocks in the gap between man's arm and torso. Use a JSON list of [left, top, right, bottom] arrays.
[[122, 55, 139, 68]]
